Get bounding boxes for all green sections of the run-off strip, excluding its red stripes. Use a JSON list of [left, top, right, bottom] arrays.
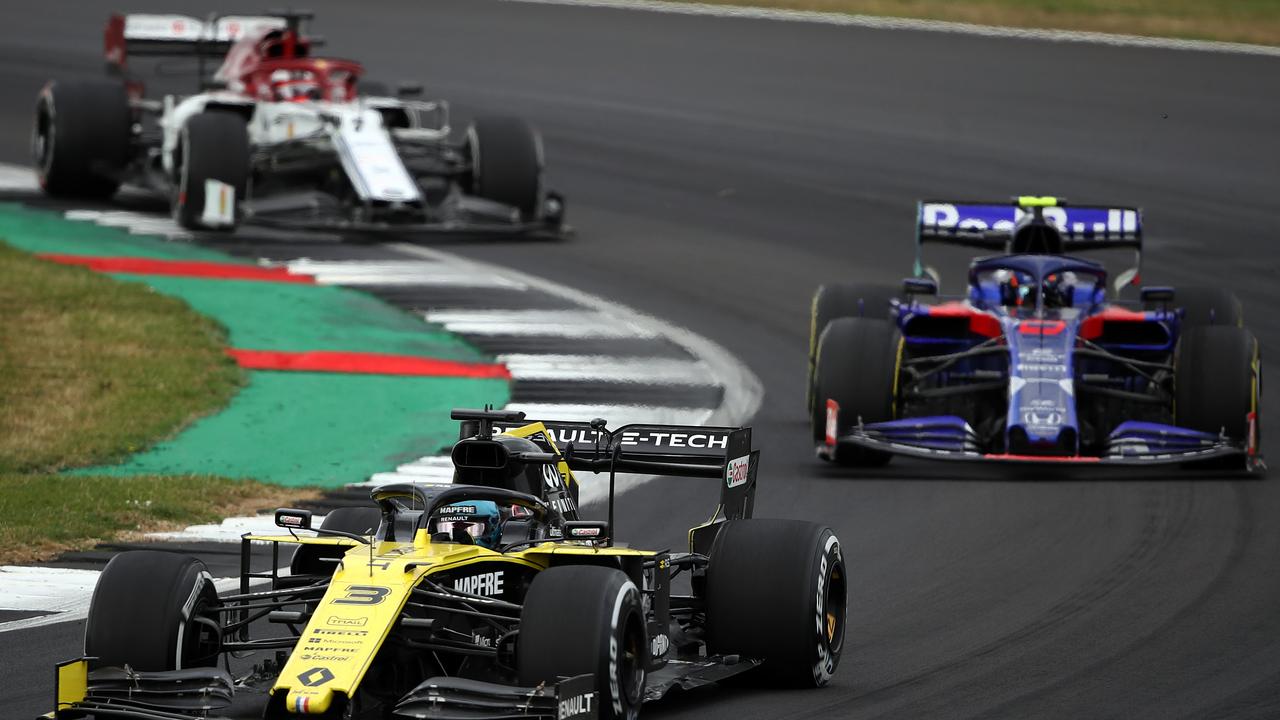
[[0, 204, 511, 487]]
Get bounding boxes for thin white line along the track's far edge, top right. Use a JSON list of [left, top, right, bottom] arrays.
[[506, 0, 1280, 58]]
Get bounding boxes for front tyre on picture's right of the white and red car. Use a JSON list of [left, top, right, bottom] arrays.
[[466, 117, 543, 223]]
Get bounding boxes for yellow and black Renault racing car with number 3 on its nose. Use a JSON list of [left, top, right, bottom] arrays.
[[45, 410, 847, 720]]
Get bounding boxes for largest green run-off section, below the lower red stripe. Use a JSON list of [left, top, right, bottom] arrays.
[[76, 373, 508, 488]]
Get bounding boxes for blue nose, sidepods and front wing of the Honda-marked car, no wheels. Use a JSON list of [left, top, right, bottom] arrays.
[[819, 251, 1252, 464]]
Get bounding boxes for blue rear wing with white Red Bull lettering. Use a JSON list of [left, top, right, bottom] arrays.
[[914, 196, 1142, 288]]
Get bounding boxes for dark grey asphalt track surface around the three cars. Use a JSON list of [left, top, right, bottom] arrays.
[[0, 0, 1280, 719]]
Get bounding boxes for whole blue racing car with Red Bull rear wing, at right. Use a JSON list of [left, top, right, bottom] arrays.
[[809, 197, 1263, 471]]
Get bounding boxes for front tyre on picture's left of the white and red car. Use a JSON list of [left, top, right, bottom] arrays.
[[173, 110, 250, 231]]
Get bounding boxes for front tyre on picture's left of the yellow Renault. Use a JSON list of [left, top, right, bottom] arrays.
[[84, 550, 221, 671]]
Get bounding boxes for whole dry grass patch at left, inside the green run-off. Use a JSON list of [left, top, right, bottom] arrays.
[[0, 243, 314, 564]]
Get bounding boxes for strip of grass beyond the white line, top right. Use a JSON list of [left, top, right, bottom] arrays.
[[673, 0, 1280, 45]]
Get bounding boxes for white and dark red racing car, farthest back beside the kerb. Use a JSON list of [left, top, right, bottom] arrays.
[[32, 13, 564, 234]]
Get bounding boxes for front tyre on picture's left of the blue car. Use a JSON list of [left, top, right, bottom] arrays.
[[810, 318, 902, 466]]
